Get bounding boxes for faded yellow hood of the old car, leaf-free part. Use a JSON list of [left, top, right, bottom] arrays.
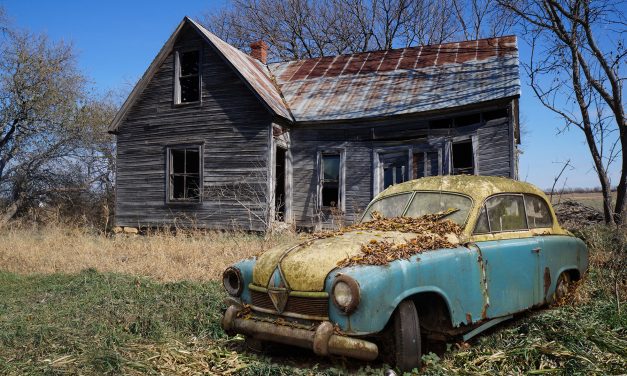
[[253, 230, 458, 291]]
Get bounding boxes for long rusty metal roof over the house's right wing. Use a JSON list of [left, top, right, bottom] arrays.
[[269, 36, 520, 122]]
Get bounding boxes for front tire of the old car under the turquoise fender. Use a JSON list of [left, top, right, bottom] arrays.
[[394, 300, 422, 372]]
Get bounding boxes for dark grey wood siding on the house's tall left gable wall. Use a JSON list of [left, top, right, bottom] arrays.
[[116, 28, 272, 230]]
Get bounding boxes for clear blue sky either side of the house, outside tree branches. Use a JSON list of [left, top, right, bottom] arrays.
[[0, 0, 618, 188]]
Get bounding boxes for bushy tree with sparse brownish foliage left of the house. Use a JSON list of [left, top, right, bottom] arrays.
[[0, 19, 115, 226]]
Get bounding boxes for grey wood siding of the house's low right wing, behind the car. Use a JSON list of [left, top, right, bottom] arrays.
[[290, 102, 515, 227]]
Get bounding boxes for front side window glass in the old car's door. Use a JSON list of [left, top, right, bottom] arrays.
[[486, 195, 527, 232]]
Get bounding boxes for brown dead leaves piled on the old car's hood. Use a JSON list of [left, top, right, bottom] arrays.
[[314, 211, 462, 267]]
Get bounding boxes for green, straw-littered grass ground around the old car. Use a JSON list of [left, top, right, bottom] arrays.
[[0, 225, 627, 375]]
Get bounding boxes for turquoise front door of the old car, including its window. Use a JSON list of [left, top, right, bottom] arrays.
[[475, 194, 542, 318]]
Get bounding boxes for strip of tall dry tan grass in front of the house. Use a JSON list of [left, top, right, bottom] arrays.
[[0, 225, 295, 281]]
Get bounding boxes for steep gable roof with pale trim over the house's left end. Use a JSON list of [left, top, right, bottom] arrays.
[[109, 17, 293, 132]]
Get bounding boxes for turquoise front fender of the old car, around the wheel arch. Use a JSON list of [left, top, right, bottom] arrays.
[[325, 247, 484, 335]]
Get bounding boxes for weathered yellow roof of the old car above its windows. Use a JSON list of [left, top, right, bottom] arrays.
[[376, 175, 548, 203]]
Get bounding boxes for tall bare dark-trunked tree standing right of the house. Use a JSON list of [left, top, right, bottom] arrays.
[[499, 0, 627, 223]]
